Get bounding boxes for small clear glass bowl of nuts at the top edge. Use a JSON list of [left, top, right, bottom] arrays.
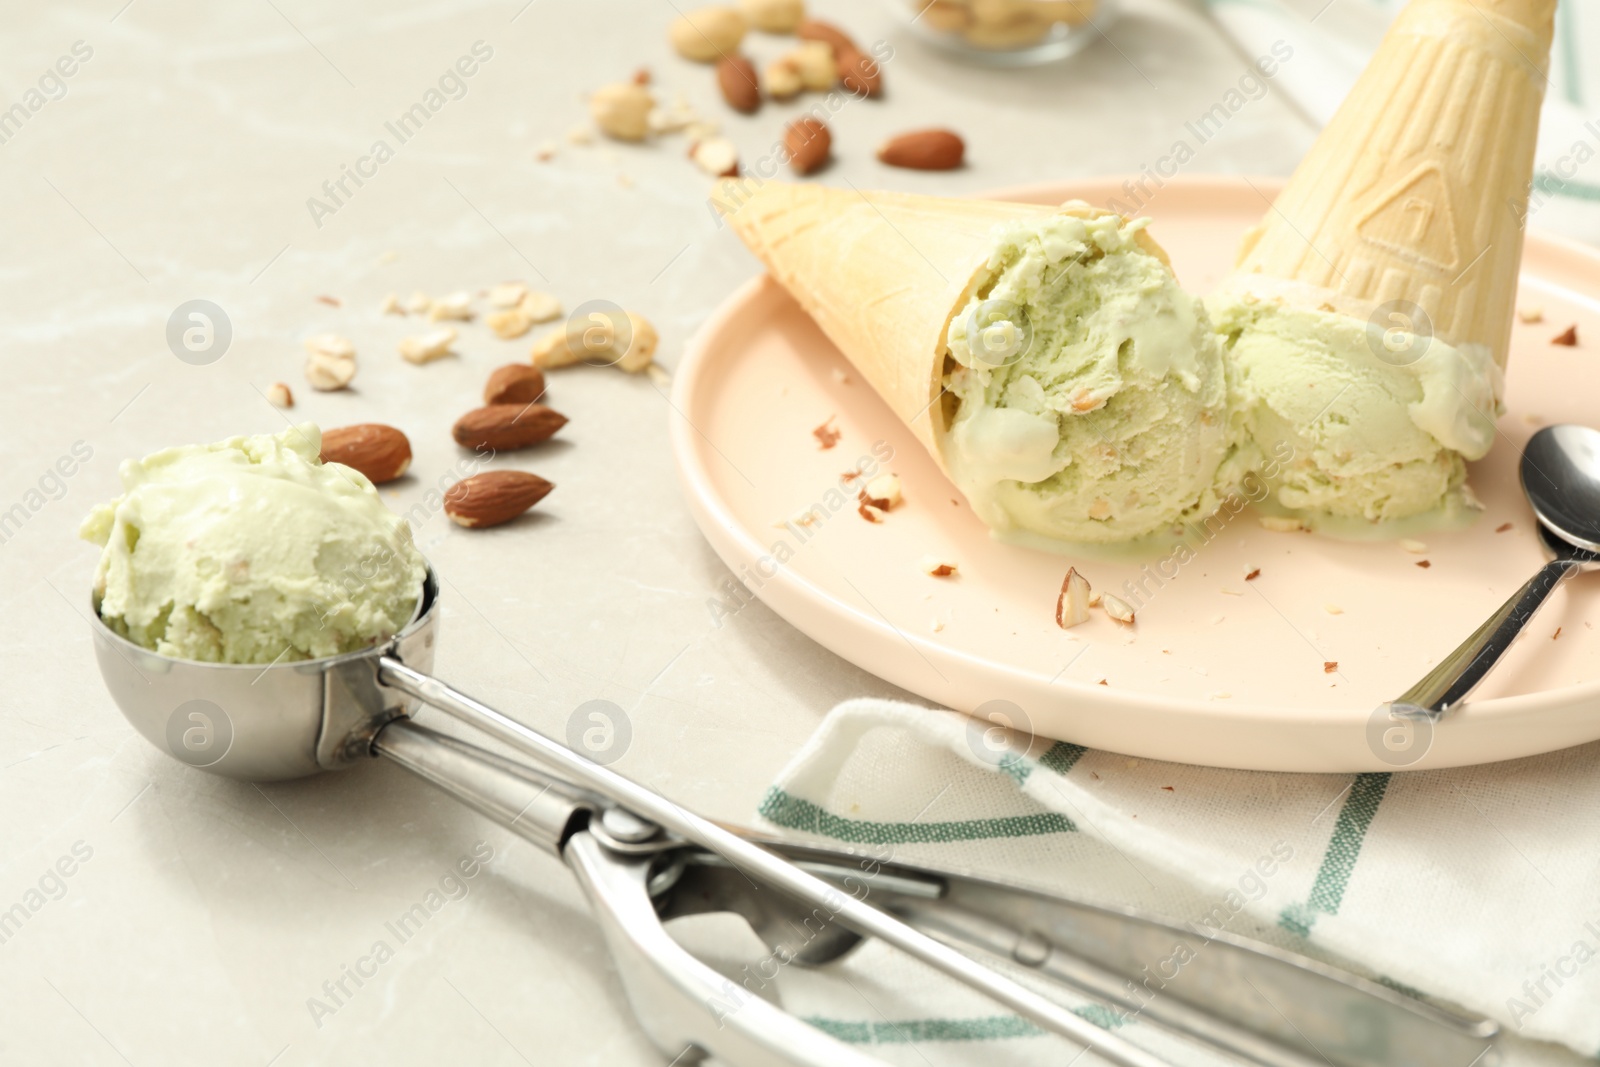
[[885, 0, 1117, 67]]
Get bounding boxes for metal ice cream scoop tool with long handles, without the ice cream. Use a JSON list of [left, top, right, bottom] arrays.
[[94, 571, 1498, 1067]]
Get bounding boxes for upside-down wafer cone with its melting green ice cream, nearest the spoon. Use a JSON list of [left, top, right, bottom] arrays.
[[1211, 0, 1555, 522]]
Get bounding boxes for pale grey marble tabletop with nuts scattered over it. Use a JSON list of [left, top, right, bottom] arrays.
[[0, 0, 1312, 1067]]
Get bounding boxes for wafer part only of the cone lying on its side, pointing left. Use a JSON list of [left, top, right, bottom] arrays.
[[715, 179, 1165, 466]]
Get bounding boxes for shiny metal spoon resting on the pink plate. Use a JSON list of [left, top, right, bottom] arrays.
[[1390, 426, 1600, 720]]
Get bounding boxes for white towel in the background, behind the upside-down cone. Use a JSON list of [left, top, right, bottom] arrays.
[[1205, 0, 1600, 243]]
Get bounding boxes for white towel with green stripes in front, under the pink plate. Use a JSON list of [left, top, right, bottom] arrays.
[[760, 699, 1600, 1067]]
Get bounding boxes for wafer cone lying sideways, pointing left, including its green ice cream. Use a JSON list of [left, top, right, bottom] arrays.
[[717, 181, 1227, 541]]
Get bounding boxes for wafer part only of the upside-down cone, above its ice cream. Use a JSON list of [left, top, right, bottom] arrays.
[[1230, 0, 1555, 368]]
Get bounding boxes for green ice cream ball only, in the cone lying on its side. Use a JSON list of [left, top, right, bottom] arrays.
[[944, 211, 1232, 544]]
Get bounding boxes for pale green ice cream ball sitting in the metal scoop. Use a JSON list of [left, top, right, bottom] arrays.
[[80, 422, 427, 664]]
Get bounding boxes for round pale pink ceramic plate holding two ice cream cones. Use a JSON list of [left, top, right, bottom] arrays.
[[672, 178, 1600, 771]]
